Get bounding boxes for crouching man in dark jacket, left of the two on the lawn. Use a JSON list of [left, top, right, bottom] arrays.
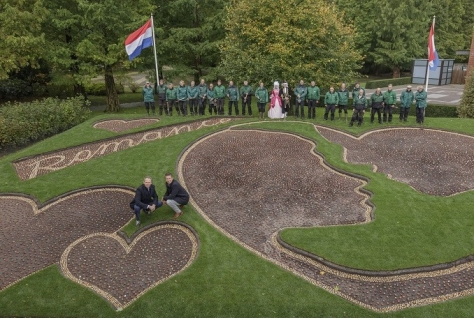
[[130, 176, 163, 226]]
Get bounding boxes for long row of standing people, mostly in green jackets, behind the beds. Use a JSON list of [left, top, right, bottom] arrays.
[[143, 79, 426, 125]]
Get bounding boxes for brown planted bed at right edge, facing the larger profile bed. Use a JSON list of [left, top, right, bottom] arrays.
[[317, 126, 474, 196]]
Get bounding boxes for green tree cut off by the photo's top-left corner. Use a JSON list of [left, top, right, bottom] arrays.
[[0, 0, 45, 79]]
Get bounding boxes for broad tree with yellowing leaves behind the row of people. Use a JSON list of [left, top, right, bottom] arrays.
[[220, 0, 362, 86]]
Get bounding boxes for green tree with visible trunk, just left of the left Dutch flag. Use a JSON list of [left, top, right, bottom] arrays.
[[43, 0, 154, 112]]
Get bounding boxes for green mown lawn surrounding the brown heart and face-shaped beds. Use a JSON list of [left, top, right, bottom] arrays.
[[0, 108, 474, 317]]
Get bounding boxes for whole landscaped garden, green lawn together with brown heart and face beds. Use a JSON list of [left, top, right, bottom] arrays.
[[0, 104, 474, 317]]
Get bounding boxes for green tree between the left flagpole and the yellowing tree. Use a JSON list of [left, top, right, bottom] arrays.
[[151, 0, 229, 81]]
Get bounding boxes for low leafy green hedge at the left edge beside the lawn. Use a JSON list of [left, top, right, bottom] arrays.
[[0, 96, 91, 148]]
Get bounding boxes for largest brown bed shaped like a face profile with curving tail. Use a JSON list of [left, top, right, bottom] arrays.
[[180, 131, 474, 311]]
